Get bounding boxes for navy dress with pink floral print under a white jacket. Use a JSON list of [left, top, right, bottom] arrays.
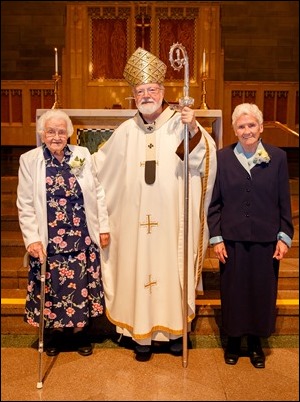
[[24, 145, 104, 328]]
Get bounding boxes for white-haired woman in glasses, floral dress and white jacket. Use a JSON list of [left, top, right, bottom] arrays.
[[17, 109, 110, 356]]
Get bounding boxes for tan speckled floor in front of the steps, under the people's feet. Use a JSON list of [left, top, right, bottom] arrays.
[[1, 335, 299, 401]]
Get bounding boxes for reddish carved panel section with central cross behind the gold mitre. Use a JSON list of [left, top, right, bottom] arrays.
[[88, 3, 199, 82]]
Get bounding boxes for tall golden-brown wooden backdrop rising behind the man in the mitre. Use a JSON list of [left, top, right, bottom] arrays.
[[62, 1, 223, 109]]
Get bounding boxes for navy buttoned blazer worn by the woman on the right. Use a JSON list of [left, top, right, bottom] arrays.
[[207, 143, 294, 242]]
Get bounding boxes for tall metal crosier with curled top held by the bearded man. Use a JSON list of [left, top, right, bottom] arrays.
[[169, 43, 194, 367]]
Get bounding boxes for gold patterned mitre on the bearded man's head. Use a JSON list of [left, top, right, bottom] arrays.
[[123, 47, 167, 86]]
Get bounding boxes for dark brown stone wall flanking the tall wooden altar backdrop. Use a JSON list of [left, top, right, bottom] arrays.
[[1, 1, 299, 81]]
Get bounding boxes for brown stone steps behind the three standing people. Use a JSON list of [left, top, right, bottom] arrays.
[[1, 177, 299, 335]]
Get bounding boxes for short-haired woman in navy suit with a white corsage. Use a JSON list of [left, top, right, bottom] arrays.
[[208, 103, 294, 368]]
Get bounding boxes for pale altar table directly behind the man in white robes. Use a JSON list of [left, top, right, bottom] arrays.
[[36, 109, 223, 153]]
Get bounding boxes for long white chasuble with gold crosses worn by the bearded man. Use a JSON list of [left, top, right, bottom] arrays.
[[93, 107, 216, 344]]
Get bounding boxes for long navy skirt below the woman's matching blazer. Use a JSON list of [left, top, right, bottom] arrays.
[[220, 241, 279, 337]]
